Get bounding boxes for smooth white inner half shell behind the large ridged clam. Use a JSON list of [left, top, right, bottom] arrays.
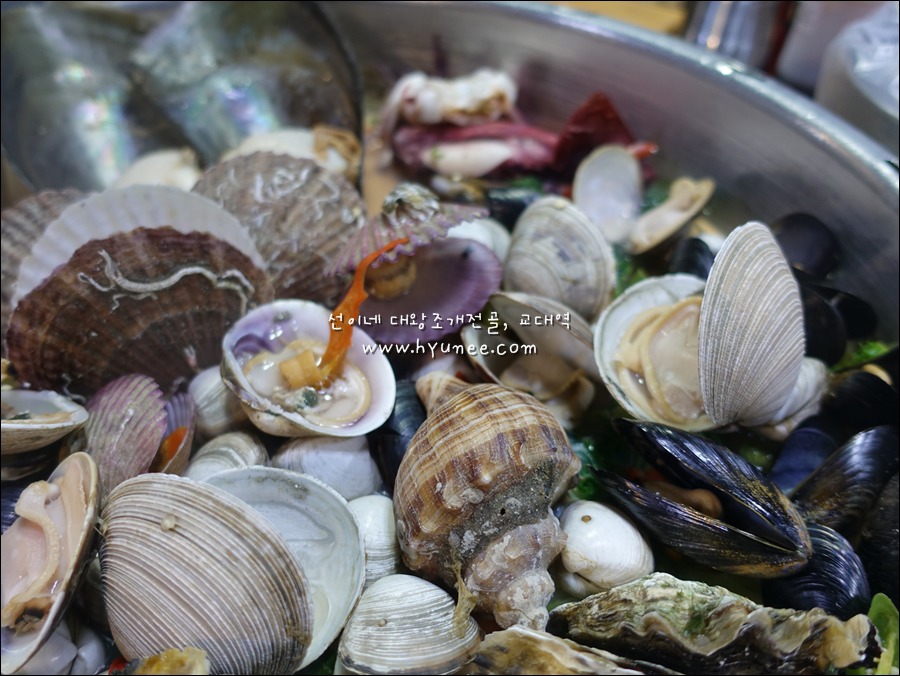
[[209, 466, 365, 667]]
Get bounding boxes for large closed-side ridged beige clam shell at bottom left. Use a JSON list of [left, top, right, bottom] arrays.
[[100, 474, 313, 674]]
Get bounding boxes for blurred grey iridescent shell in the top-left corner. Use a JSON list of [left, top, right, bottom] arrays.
[[2, 3, 183, 190]]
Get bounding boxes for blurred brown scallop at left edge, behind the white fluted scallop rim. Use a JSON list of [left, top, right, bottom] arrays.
[[0, 189, 84, 354]]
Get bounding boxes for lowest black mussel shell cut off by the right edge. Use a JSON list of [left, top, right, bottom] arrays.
[[857, 474, 900, 606]]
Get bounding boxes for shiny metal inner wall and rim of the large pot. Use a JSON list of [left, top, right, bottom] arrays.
[[333, 1, 900, 341]]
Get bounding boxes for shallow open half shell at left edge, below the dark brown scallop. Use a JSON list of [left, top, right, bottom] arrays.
[[0, 390, 88, 455]]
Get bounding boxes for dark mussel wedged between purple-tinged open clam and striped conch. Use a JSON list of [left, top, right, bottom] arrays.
[[367, 380, 425, 493]]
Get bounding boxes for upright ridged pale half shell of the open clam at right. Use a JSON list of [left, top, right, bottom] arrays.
[[697, 222, 806, 426]]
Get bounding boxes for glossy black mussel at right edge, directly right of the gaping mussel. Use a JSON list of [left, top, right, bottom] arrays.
[[791, 425, 900, 540]]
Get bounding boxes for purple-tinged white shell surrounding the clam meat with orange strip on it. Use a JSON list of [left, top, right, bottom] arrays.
[[222, 300, 397, 437]]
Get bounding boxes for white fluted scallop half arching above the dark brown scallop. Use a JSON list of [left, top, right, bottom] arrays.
[[11, 185, 263, 307]]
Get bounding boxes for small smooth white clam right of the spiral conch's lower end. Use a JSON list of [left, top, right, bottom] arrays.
[[556, 500, 653, 598]]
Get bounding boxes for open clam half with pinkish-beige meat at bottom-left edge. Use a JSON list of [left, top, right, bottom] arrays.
[[2, 453, 100, 674]]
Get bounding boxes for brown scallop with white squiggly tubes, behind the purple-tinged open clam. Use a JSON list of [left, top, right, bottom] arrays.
[[193, 152, 365, 307]]
